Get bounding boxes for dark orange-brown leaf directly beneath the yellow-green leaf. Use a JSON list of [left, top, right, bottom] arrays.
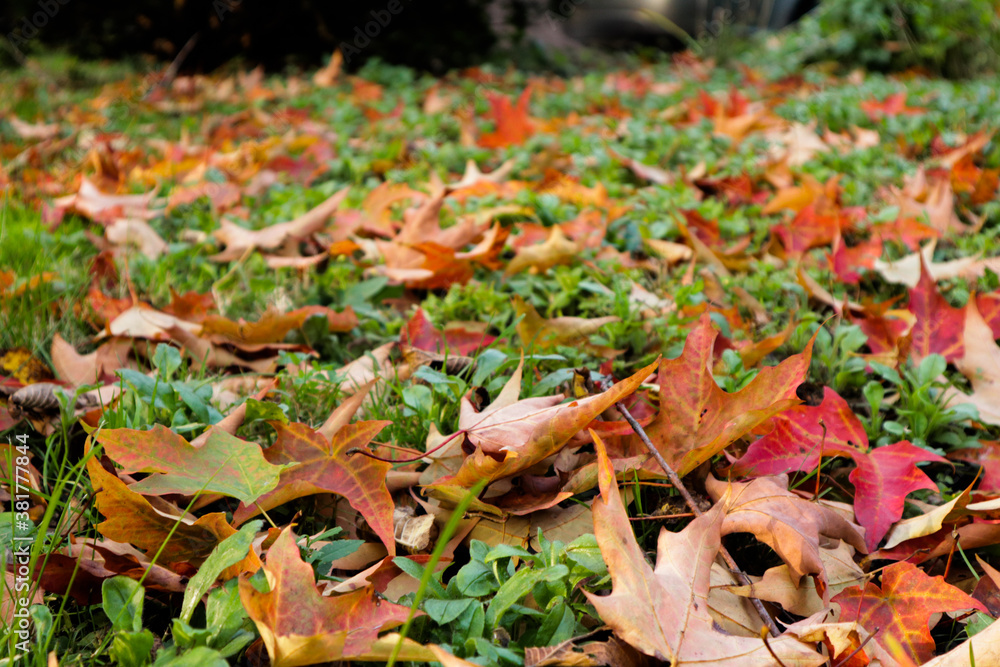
[[87, 457, 236, 564]]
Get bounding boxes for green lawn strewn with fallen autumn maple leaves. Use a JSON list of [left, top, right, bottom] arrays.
[[0, 34, 1000, 666]]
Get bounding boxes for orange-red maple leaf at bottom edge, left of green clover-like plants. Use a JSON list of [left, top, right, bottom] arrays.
[[240, 528, 410, 667]]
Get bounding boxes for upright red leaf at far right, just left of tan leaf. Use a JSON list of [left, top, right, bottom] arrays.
[[909, 253, 965, 361]]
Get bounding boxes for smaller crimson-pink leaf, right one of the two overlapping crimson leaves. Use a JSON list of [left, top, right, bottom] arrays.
[[848, 440, 948, 552]]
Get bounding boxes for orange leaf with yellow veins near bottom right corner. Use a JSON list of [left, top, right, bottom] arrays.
[[833, 562, 987, 665]]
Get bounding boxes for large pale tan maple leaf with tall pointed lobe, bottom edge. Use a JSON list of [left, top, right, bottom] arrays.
[[584, 438, 824, 667]]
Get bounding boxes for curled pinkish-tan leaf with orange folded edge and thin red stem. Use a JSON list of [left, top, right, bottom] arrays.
[[432, 360, 659, 488]]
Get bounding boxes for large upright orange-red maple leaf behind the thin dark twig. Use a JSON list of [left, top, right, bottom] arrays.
[[638, 314, 812, 476]]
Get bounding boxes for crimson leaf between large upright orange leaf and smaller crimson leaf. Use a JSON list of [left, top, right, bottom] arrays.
[[733, 387, 868, 477]]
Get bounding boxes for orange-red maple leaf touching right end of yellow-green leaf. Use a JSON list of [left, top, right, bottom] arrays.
[[233, 394, 396, 555]]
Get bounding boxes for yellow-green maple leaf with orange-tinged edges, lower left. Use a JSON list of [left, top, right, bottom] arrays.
[[96, 425, 281, 503]]
